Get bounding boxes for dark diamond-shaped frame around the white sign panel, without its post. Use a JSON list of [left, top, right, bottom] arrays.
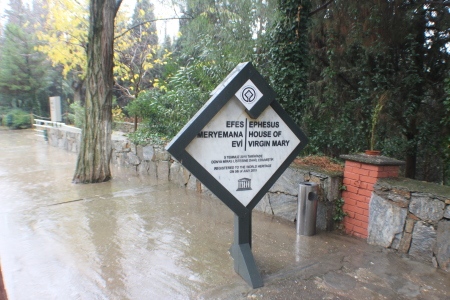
[[166, 63, 308, 216]]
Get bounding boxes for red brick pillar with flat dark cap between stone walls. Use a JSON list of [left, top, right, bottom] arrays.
[[341, 154, 404, 238]]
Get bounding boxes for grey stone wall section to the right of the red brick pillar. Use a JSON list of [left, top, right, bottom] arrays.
[[367, 178, 450, 272]]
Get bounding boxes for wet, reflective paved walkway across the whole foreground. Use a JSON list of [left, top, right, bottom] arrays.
[[0, 129, 450, 300]]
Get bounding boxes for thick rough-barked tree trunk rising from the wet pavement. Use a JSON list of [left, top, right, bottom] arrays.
[[73, 0, 120, 183]]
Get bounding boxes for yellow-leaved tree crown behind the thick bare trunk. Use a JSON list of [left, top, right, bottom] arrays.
[[38, 0, 170, 105]]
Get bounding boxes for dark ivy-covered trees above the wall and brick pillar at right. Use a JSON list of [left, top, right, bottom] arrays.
[[266, 0, 450, 183]]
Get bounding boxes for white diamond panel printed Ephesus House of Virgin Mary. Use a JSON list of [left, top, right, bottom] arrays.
[[186, 97, 300, 206]]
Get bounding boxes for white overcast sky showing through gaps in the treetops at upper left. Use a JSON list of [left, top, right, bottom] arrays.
[[0, 0, 179, 42]]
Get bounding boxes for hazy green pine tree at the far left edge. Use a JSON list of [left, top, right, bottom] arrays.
[[0, 0, 51, 114]]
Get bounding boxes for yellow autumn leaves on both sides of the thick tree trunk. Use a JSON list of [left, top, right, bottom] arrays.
[[37, 0, 171, 97]]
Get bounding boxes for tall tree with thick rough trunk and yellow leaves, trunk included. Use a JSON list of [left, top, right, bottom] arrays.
[[40, 0, 175, 183]]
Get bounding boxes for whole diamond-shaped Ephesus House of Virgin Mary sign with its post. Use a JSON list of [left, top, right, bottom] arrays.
[[166, 63, 308, 288]]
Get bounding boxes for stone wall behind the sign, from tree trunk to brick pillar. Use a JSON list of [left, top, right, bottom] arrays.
[[111, 141, 342, 230]]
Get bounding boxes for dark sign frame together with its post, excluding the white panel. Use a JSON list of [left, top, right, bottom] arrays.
[[166, 62, 308, 288]]
